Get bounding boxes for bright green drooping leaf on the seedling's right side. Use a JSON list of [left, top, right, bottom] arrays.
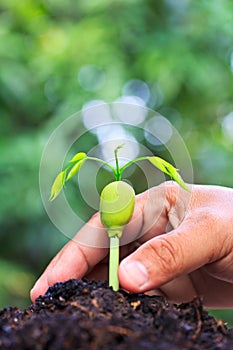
[[148, 157, 189, 191]]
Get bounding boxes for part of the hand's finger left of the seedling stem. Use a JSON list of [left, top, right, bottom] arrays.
[[31, 215, 108, 301]]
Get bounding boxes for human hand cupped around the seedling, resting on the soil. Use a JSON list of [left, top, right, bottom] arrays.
[[31, 181, 233, 307]]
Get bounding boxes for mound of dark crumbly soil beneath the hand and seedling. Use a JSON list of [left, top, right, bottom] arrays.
[[0, 280, 233, 350]]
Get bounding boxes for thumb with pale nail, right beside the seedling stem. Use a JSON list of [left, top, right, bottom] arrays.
[[119, 215, 221, 293]]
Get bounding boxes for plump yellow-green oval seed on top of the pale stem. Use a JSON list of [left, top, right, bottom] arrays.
[[100, 181, 135, 237]]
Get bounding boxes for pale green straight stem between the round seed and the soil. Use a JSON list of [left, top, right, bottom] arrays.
[[109, 236, 119, 291]]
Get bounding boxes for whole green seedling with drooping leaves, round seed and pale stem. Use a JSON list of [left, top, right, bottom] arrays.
[[50, 145, 188, 290]]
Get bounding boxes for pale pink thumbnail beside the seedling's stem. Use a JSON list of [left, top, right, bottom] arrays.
[[122, 261, 149, 288]]
